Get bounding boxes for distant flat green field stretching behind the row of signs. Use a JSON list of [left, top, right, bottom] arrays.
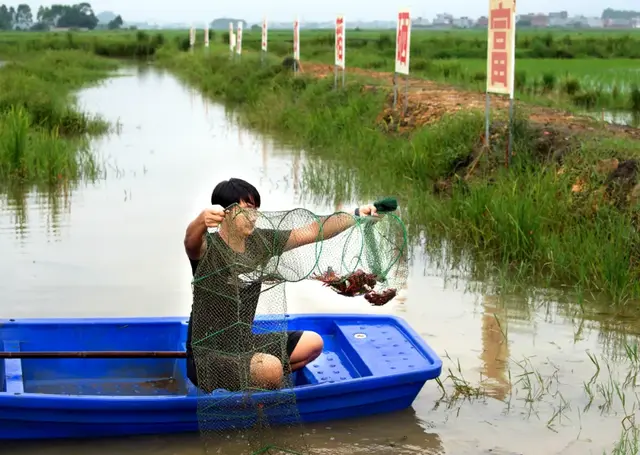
[[0, 28, 640, 112]]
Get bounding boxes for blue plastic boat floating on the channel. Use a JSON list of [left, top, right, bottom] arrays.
[[0, 314, 442, 440]]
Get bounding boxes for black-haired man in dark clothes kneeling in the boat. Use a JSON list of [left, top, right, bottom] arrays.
[[184, 178, 376, 393]]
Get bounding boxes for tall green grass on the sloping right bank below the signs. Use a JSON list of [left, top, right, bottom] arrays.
[[163, 49, 640, 305]]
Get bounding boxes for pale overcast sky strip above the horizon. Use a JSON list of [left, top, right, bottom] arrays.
[[10, 0, 640, 22]]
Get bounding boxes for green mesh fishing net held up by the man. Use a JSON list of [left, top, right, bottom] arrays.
[[191, 200, 407, 454]]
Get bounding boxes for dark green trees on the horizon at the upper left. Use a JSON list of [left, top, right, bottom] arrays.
[[0, 3, 123, 31]]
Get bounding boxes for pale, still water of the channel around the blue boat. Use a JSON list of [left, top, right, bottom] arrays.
[[0, 67, 638, 455]]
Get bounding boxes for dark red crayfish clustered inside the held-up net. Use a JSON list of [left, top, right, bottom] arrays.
[[313, 267, 396, 306]]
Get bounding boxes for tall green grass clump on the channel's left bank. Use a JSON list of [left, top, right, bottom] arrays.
[[0, 51, 117, 186]]
